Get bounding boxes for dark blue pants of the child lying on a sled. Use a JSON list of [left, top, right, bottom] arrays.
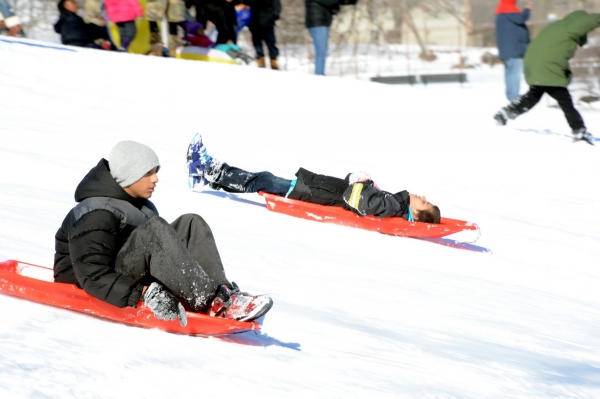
[[211, 163, 292, 196]]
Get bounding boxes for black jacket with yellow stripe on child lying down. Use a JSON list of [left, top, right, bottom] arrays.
[[288, 168, 410, 220]]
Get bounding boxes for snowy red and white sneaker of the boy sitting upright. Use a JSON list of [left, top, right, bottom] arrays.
[[209, 282, 273, 321]]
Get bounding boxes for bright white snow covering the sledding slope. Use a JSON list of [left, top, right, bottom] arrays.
[[0, 39, 600, 398]]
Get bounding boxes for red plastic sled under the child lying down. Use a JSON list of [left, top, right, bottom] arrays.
[[259, 192, 479, 242]]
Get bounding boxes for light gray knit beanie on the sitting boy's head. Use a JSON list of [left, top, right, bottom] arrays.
[[108, 141, 160, 187]]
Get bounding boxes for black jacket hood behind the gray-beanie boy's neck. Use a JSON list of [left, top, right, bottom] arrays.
[[75, 158, 147, 208]]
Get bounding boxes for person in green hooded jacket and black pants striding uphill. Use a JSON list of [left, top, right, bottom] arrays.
[[494, 10, 600, 145]]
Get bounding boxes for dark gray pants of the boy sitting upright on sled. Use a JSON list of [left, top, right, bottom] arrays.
[[115, 214, 231, 311]]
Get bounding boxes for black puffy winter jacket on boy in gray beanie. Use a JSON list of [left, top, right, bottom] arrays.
[[54, 159, 158, 308]]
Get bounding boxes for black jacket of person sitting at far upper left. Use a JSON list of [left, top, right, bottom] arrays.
[[54, 10, 108, 47]]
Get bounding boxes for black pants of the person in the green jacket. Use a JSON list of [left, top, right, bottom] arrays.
[[506, 86, 585, 130]]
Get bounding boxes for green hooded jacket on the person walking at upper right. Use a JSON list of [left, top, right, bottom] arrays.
[[523, 10, 600, 87]]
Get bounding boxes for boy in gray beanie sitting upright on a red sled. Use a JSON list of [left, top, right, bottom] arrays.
[[54, 141, 273, 326]]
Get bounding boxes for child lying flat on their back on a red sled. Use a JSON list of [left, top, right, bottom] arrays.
[[187, 134, 440, 224]]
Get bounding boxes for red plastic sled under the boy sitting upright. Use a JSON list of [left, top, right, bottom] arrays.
[[0, 260, 260, 336]]
